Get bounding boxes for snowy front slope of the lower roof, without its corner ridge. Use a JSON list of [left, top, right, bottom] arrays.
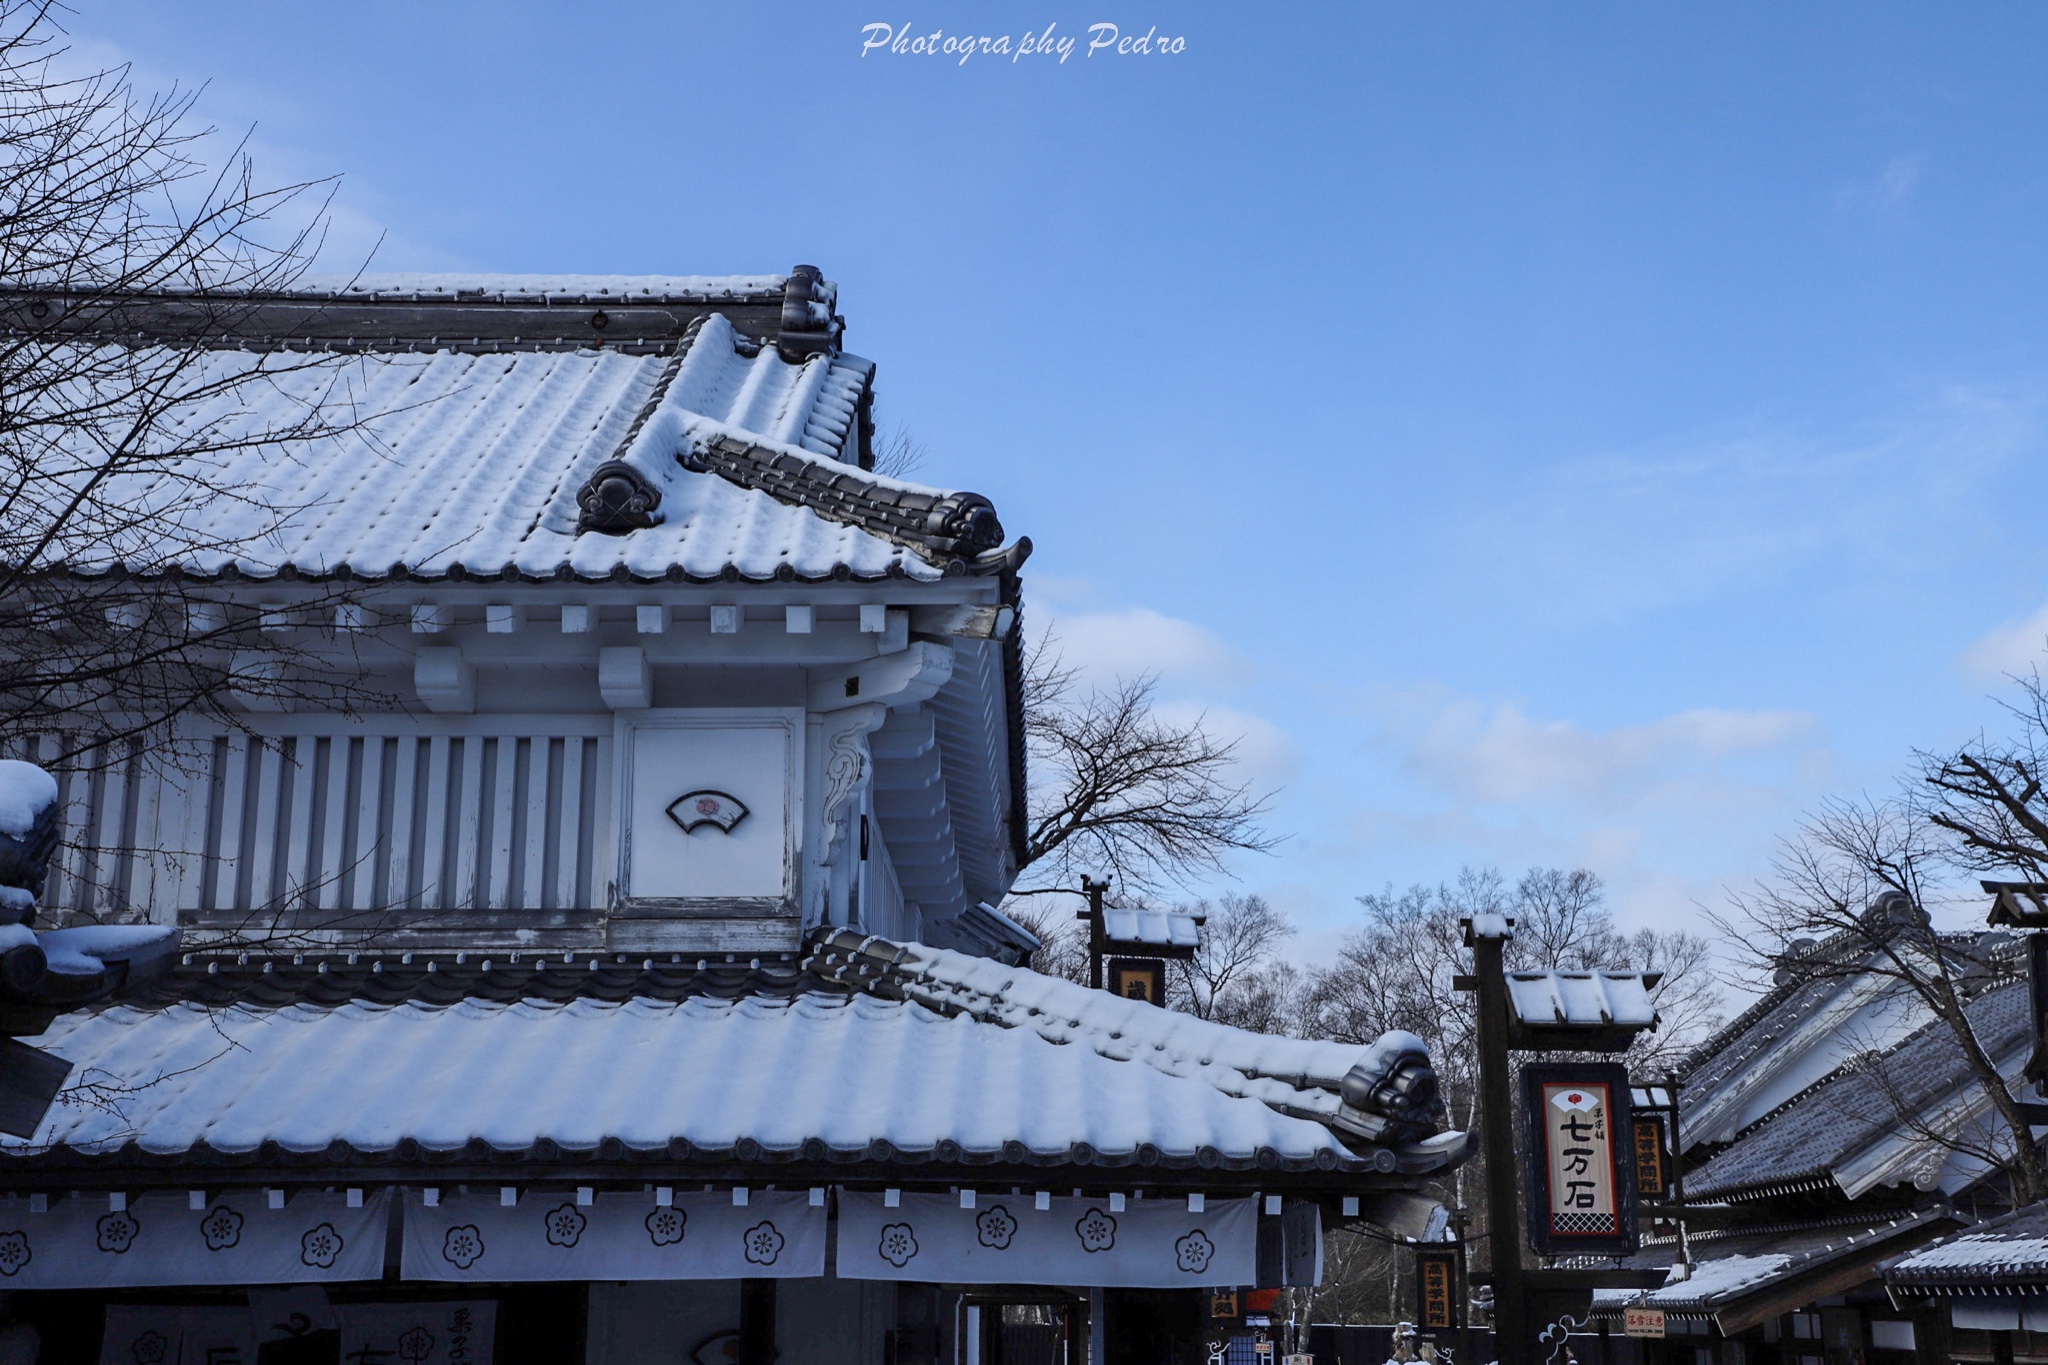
[[6, 993, 1350, 1169]]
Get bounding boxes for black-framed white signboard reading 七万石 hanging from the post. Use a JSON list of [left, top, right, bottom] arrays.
[[1522, 1062, 1636, 1254]]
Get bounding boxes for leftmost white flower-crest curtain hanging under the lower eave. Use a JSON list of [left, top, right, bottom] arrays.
[[0, 1189, 387, 1289]]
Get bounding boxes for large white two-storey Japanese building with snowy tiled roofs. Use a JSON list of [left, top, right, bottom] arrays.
[[0, 266, 1466, 1365]]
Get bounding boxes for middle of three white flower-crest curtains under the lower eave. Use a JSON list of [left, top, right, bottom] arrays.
[[403, 1187, 825, 1283]]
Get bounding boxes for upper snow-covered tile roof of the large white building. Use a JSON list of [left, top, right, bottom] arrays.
[[36, 315, 1001, 579]]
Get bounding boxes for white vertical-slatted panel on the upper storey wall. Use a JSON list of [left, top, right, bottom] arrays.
[[0, 716, 610, 921]]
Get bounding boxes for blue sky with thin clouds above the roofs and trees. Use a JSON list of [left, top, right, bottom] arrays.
[[70, 0, 2048, 948]]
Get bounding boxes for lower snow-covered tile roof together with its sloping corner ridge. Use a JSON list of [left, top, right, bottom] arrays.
[[0, 950, 1444, 1171]]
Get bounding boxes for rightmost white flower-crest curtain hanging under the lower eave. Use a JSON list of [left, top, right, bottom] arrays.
[[838, 1191, 1257, 1289]]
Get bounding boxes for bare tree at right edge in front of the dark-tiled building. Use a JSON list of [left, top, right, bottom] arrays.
[[1718, 794, 2048, 1203]]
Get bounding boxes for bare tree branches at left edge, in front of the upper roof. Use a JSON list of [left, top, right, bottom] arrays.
[[0, 0, 387, 767]]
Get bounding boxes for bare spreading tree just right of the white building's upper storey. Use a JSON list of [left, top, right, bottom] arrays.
[[1014, 639, 1278, 898]]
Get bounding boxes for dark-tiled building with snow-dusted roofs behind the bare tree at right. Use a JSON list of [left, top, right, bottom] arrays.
[[1595, 896, 2038, 1365]]
